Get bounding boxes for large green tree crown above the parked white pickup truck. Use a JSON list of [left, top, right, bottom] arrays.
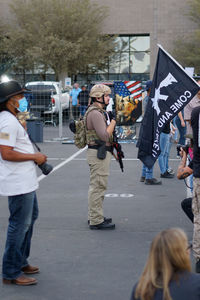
[[2, 0, 115, 78]]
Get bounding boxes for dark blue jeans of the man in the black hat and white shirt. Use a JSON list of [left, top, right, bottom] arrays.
[[2, 192, 38, 279]]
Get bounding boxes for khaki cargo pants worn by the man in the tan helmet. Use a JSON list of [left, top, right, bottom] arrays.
[[87, 149, 112, 225]]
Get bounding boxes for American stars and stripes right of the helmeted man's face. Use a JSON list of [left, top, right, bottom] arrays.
[[114, 81, 142, 101]]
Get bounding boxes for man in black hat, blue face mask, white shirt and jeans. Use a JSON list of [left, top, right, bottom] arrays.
[[0, 80, 47, 285]]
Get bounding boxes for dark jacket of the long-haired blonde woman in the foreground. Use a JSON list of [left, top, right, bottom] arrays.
[[130, 272, 200, 300]]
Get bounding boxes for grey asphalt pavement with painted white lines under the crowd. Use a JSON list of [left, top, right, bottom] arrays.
[[0, 142, 194, 300]]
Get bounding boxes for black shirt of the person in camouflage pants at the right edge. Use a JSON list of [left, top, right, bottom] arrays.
[[191, 106, 200, 178]]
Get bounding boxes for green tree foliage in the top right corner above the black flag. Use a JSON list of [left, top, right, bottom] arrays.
[[173, 0, 200, 73]]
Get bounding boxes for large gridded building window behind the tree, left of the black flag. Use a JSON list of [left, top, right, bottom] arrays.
[[77, 35, 150, 81]]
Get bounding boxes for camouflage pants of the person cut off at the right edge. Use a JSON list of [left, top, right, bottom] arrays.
[[192, 177, 200, 259]]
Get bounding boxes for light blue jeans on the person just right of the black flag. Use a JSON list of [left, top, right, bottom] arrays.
[[158, 132, 170, 174]]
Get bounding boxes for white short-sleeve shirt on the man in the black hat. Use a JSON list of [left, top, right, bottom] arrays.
[[0, 111, 38, 196]]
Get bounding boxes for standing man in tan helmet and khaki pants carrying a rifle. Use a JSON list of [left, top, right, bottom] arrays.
[[85, 84, 116, 230]]
